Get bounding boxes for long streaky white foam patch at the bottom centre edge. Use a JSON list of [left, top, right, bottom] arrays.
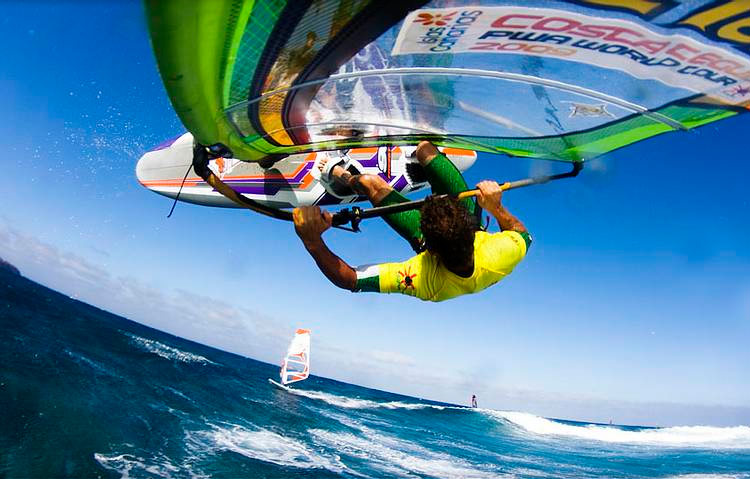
[[308, 426, 509, 479]]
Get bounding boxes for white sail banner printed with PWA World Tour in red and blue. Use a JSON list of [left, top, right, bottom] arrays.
[[392, 6, 750, 104]]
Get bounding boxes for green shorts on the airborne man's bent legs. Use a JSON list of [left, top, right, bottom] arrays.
[[376, 153, 478, 253]]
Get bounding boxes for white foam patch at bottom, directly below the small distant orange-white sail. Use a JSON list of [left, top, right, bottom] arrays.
[[198, 425, 346, 472]]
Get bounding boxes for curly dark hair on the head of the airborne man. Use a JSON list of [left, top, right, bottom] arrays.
[[420, 196, 477, 266]]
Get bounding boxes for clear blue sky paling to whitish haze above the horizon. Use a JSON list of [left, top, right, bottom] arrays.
[[0, 2, 750, 424]]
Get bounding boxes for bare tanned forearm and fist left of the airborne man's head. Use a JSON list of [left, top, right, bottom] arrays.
[[294, 206, 357, 291]]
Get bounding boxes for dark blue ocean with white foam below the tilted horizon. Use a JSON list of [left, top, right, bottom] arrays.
[[0, 271, 750, 479]]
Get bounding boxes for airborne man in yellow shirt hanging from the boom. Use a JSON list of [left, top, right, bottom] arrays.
[[294, 141, 531, 301]]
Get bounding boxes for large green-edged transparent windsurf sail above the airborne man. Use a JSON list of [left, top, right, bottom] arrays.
[[146, 0, 750, 162]]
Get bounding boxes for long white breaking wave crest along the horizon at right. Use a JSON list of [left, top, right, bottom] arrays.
[[488, 409, 750, 449]]
